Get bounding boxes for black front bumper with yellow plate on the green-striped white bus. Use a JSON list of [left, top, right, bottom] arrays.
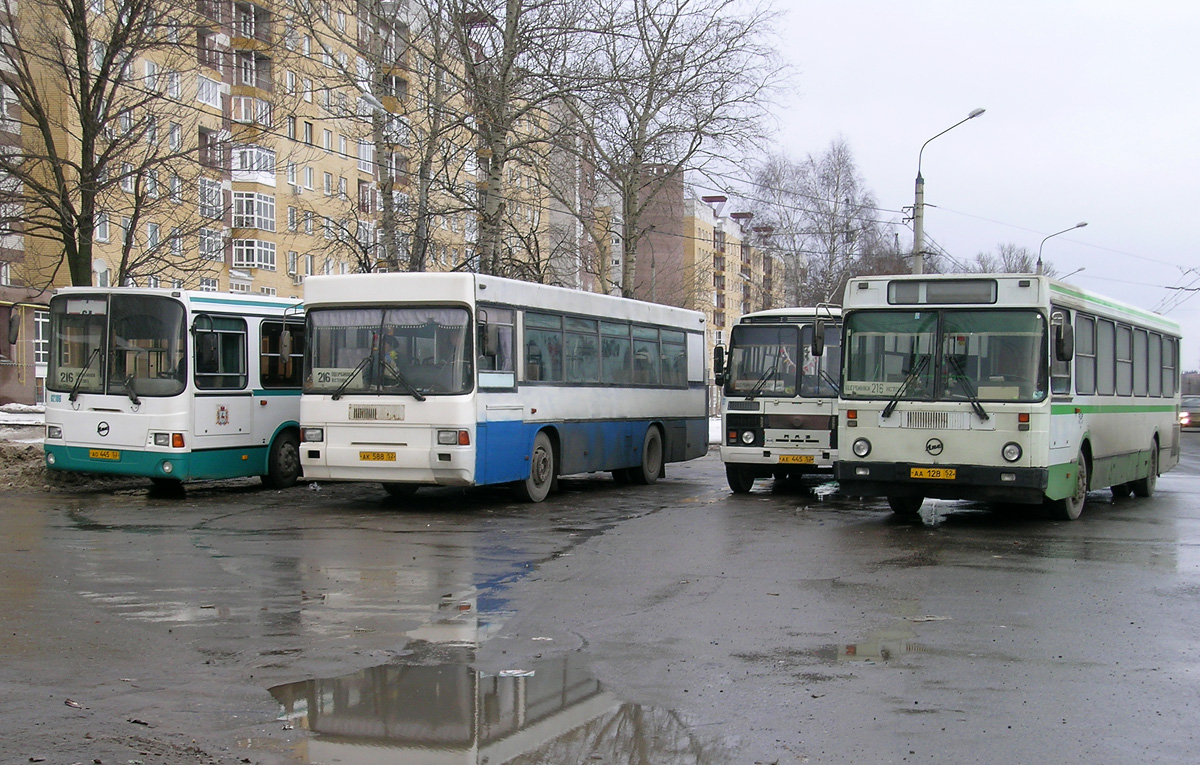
[[834, 460, 1049, 505]]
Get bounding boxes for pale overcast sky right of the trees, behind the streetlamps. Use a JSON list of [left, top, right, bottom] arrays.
[[739, 0, 1200, 369]]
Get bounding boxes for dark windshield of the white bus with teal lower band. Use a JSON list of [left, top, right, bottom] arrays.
[[47, 294, 187, 402]]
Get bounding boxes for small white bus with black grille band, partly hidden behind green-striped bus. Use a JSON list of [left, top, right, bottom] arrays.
[[713, 306, 841, 494]]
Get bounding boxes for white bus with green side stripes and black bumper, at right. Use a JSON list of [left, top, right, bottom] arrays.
[[836, 275, 1180, 519]]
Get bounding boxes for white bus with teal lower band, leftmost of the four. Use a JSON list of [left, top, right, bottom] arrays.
[[44, 287, 304, 488]]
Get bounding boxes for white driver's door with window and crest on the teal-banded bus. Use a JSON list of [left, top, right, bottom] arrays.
[[191, 314, 253, 448]]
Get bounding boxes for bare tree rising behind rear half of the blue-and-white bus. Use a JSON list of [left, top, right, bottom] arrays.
[[554, 0, 782, 302]]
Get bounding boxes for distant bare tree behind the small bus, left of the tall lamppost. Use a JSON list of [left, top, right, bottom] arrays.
[[750, 138, 904, 306]]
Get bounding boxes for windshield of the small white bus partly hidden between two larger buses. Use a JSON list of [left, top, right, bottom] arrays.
[[726, 324, 841, 398]]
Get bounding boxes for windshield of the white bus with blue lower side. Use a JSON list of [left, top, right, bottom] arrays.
[[304, 306, 474, 398]]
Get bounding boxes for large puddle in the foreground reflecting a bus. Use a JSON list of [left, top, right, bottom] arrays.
[[270, 645, 734, 765]]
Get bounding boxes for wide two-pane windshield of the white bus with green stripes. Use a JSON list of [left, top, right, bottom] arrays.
[[842, 309, 1048, 402]]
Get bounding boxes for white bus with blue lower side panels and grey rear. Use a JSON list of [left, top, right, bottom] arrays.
[[300, 273, 708, 502]]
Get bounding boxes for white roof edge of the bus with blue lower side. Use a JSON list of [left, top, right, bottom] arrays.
[[305, 272, 704, 332]]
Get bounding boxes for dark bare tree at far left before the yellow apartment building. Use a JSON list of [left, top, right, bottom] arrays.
[[0, 0, 224, 285]]
